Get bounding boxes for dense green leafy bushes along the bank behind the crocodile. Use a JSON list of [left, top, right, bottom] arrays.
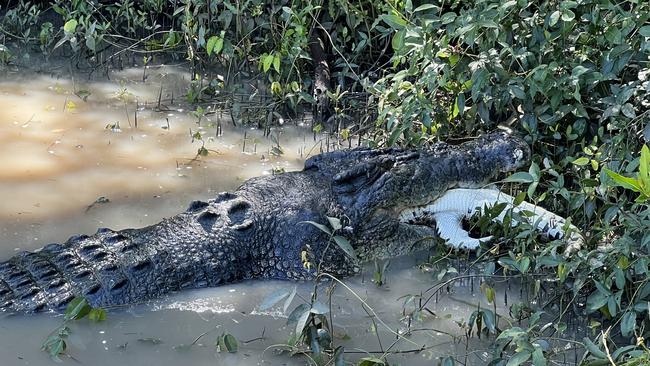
[[0, 0, 650, 365]]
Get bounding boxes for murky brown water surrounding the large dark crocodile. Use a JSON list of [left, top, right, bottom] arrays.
[[0, 67, 520, 366]]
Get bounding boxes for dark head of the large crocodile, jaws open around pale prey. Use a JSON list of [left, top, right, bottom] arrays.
[[305, 132, 530, 259]]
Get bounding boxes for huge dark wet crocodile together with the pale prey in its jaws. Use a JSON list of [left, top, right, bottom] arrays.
[[0, 132, 580, 312]]
